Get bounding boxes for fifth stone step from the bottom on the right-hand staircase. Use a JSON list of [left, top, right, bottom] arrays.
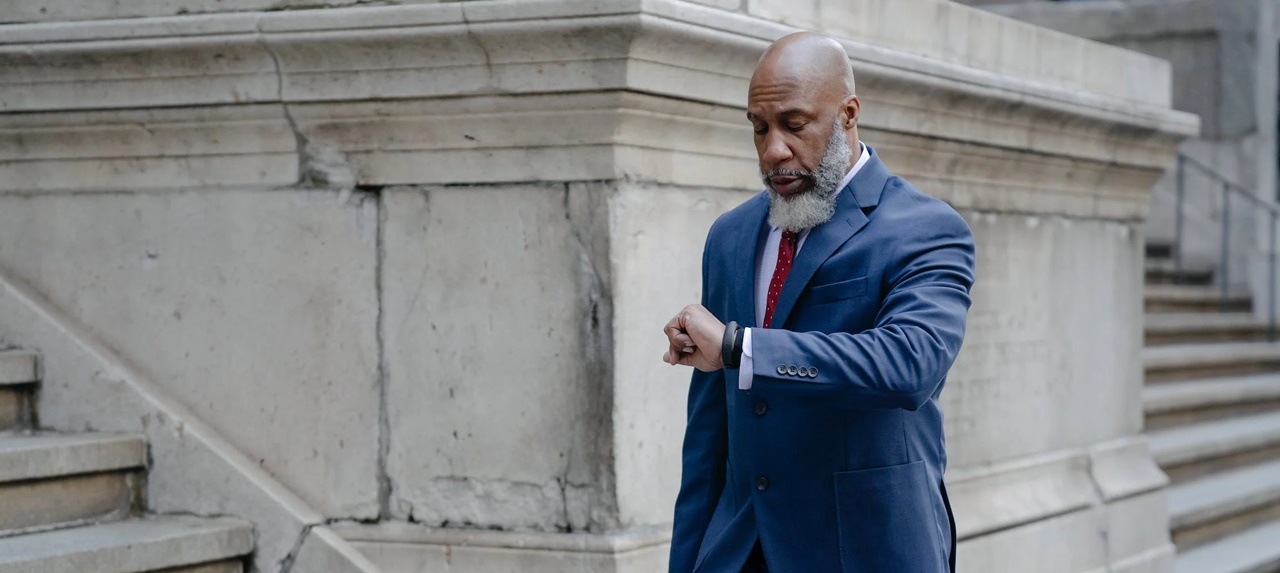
[[1142, 341, 1280, 384]]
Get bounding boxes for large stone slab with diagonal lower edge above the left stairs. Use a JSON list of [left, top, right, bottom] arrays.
[[0, 191, 378, 517]]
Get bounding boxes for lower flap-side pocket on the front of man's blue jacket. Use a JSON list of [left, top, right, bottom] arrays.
[[835, 462, 948, 573]]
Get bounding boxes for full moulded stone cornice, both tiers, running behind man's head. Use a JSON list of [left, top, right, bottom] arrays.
[[0, 0, 1198, 212]]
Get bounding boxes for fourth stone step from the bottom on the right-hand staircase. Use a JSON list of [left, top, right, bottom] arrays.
[[1142, 372, 1280, 431]]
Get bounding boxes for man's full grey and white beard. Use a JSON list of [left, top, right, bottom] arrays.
[[762, 119, 854, 233]]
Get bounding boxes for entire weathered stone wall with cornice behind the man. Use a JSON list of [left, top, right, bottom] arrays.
[[0, 0, 1197, 572]]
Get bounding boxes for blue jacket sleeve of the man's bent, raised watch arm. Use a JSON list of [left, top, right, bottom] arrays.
[[751, 203, 974, 409]]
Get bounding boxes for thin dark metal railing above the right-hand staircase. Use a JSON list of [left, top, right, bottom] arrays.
[[1172, 153, 1280, 341]]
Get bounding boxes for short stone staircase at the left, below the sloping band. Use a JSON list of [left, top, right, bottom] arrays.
[[0, 350, 253, 573]]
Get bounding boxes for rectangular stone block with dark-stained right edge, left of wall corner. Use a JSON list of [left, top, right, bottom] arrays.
[[383, 184, 616, 531]]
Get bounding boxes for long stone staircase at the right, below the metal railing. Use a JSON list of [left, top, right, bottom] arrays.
[[1142, 246, 1280, 573]]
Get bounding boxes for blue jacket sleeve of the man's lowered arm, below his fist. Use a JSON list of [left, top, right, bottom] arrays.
[[669, 230, 728, 573]]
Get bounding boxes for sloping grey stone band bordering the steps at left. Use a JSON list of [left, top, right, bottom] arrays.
[[0, 251, 374, 573]]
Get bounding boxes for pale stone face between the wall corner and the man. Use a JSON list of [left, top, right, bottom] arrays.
[[609, 184, 751, 523]]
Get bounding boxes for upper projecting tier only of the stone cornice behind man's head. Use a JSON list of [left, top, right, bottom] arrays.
[[0, 0, 1194, 128]]
